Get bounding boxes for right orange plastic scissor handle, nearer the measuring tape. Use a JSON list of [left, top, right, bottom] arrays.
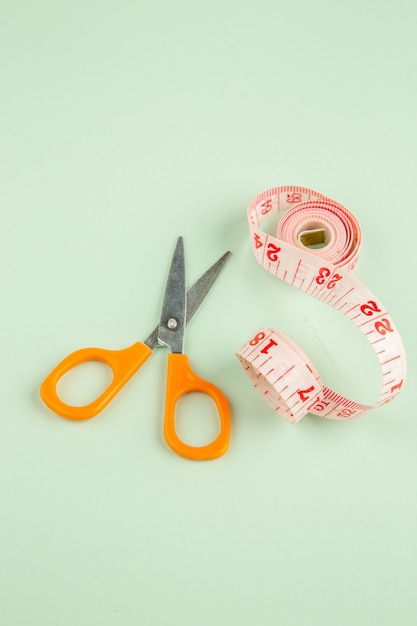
[[164, 354, 230, 461]]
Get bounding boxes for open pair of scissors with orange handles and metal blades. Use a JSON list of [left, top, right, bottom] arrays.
[[40, 237, 230, 460]]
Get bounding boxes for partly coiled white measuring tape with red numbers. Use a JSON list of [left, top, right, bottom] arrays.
[[236, 186, 407, 423]]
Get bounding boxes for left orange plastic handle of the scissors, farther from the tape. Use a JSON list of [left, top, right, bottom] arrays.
[[41, 342, 152, 420]]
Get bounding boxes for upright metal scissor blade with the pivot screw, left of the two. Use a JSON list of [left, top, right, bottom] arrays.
[[158, 237, 187, 353]]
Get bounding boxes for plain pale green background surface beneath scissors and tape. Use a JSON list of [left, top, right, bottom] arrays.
[[0, 0, 417, 626]]
